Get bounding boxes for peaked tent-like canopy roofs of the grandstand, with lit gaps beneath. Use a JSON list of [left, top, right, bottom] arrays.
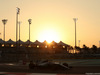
[[0, 39, 71, 48]]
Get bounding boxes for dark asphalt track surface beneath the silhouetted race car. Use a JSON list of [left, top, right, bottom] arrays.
[[0, 65, 100, 74]]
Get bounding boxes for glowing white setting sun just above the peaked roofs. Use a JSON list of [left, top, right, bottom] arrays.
[[39, 29, 59, 43]]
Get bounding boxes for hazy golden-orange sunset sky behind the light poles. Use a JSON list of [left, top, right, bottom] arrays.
[[0, 0, 100, 47]]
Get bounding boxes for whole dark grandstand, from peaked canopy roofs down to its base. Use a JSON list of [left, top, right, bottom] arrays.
[[0, 39, 71, 62]]
